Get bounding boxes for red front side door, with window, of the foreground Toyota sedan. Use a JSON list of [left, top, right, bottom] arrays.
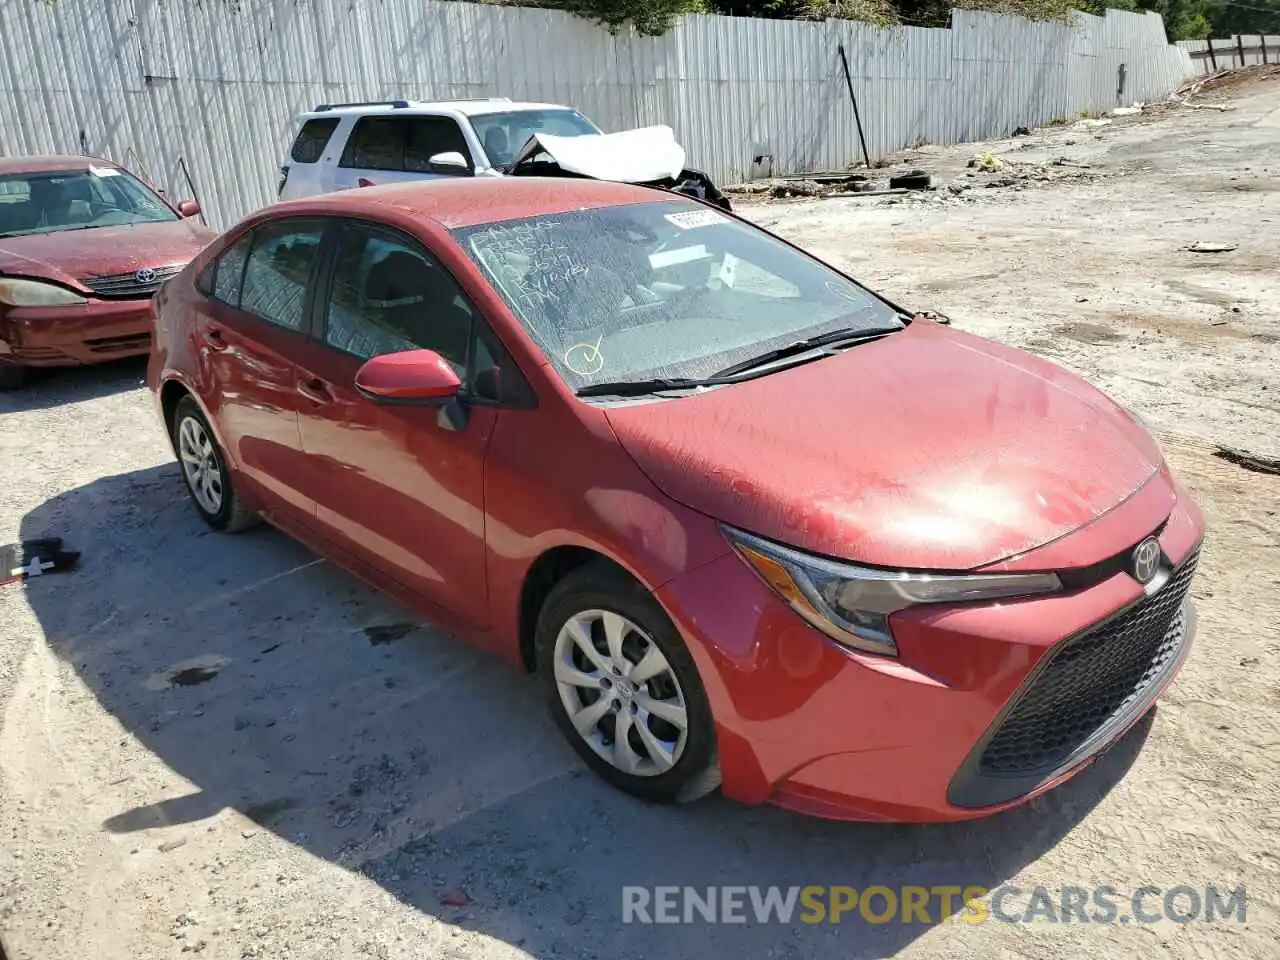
[[296, 221, 498, 628]]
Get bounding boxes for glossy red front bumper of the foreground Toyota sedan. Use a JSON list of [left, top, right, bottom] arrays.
[[658, 495, 1203, 822]]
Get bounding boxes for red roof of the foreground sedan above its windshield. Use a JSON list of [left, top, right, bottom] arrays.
[[270, 177, 692, 229]]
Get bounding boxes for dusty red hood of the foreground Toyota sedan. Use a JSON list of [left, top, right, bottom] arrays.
[[605, 320, 1162, 571]]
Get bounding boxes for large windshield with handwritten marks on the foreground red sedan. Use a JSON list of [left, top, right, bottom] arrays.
[[453, 201, 904, 390]]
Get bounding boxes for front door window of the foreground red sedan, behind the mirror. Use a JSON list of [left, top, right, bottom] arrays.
[[324, 224, 472, 378]]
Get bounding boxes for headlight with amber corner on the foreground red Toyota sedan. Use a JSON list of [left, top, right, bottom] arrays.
[[723, 527, 1062, 657]]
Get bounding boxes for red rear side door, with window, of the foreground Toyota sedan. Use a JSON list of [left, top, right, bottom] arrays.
[[197, 218, 323, 522]]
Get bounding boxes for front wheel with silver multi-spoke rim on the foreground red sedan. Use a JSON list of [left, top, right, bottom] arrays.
[[535, 562, 721, 804]]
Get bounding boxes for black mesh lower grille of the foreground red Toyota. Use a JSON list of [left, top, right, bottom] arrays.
[[978, 550, 1199, 777]]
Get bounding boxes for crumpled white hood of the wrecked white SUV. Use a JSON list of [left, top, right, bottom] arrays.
[[511, 125, 685, 183]]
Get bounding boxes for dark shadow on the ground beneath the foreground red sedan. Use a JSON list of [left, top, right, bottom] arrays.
[[22, 465, 1149, 960]]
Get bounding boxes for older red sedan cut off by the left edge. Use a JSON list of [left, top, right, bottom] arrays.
[[0, 156, 216, 389]]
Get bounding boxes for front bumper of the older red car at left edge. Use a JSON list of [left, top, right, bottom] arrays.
[[0, 300, 154, 366]]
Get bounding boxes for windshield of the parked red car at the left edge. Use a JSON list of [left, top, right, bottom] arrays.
[[0, 166, 178, 237]]
